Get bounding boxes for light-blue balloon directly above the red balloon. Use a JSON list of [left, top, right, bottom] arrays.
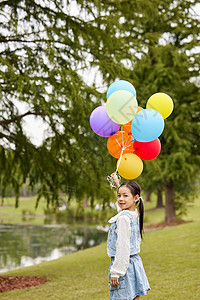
[[131, 108, 164, 142]]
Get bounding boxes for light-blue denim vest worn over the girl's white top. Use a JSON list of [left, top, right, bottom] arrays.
[[107, 210, 141, 257]]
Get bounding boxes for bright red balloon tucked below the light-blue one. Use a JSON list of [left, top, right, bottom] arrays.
[[133, 139, 161, 160]]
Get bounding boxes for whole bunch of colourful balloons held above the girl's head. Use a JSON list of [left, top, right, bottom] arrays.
[[90, 80, 174, 179]]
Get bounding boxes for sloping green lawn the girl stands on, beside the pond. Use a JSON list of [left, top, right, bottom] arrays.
[[0, 199, 200, 300]]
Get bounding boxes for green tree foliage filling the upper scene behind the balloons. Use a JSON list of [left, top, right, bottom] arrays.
[[0, 0, 200, 211]]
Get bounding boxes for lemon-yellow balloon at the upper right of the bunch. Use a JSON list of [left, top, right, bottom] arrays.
[[146, 93, 174, 119]]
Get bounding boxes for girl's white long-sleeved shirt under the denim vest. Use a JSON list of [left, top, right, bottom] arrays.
[[108, 209, 138, 278]]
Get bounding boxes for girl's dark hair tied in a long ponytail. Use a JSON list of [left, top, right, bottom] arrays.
[[118, 180, 144, 237]]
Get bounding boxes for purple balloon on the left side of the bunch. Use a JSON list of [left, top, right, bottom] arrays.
[[90, 105, 120, 137]]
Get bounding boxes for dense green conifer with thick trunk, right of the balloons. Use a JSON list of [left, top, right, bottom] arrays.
[[126, 1, 200, 222]]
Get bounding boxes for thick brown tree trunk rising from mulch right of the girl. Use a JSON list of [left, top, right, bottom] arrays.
[[164, 179, 176, 223]]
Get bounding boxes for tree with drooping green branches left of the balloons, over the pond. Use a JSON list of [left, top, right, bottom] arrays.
[[0, 0, 129, 204]]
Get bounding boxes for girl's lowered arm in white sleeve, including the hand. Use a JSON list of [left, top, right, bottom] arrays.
[[110, 216, 131, 286]]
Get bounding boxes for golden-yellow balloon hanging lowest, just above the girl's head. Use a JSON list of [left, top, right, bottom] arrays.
[[117, 153, 143, 179]]
